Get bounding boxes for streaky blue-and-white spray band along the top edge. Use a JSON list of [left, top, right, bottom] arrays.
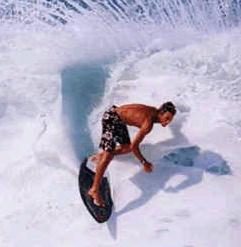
[[0, 0, 241, 31]]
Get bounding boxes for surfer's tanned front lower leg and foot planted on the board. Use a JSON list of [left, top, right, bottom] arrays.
[[88, 151, 114, 206]]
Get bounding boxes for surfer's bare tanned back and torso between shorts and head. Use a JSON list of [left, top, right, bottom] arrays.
[[116, 104, 157, 128]]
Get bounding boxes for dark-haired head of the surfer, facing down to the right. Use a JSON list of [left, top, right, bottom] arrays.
[[158, 101, 177, 127]]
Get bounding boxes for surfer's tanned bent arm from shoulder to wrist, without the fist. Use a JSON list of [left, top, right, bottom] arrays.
[[131, 121, 153, 164]]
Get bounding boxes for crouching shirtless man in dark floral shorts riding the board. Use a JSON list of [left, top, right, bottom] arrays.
[[88, 102, 176, 207]]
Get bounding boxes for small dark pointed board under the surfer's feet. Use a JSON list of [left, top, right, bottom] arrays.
[[79, 158, 113, 223]]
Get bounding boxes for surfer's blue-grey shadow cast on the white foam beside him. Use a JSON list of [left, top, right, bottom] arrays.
[[114, 111, 231, 217]]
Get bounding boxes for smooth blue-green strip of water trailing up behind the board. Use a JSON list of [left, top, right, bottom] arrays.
[[61, 63, 109, 160]]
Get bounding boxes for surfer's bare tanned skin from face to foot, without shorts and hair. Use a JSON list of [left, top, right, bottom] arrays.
[[88, 104, 173, 206]]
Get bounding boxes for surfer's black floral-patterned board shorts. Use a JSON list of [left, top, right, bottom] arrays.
[[99, 105, 131, 152]]
